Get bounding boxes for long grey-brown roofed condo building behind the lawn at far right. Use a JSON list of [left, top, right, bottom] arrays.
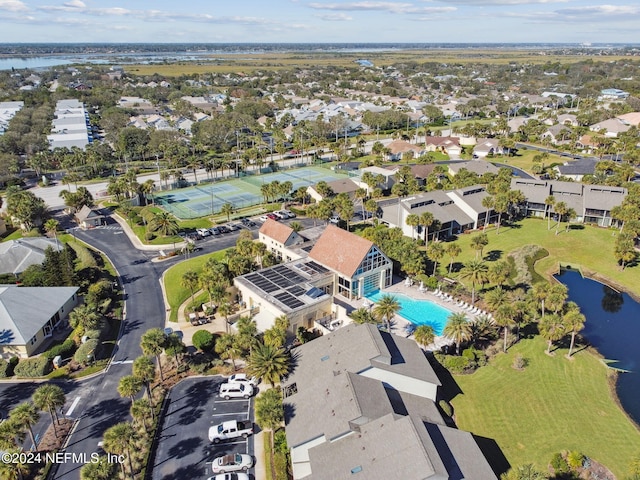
[[511, 178, 627, 227]]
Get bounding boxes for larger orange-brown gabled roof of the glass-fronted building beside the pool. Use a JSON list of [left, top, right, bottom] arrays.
[[309, 225, 373, 278]]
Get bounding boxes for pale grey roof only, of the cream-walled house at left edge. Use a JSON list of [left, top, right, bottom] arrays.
[[0, 286, 78, 345]]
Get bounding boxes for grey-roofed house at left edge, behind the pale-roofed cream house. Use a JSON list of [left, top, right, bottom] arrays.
[[0, 237, 62, 275]]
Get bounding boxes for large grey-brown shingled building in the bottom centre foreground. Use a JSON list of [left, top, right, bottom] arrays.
[[283, 324, 497, 480]]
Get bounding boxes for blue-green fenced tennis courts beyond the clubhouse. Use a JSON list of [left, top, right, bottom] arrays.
[[155, 167, 347, 219]]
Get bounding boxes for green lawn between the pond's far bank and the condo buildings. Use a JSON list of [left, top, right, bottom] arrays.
[[448, 218, 640, 296]]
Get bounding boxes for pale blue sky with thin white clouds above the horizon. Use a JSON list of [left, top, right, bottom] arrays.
[[0, 0, 640, 44]]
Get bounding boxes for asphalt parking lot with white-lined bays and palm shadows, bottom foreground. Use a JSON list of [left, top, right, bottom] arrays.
[[152, 376, 258, 480]]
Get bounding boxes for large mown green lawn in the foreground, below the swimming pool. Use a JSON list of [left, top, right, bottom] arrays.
[[452, 337, 640, 478]]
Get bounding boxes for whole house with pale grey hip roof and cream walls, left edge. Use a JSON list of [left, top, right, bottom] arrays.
[[0, 286, 78, 359]]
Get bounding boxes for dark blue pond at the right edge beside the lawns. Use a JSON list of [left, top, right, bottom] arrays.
[[556, 270, 640, 424]]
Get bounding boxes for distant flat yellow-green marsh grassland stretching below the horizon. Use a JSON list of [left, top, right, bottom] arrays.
[[125, 49, 626, 77]]
